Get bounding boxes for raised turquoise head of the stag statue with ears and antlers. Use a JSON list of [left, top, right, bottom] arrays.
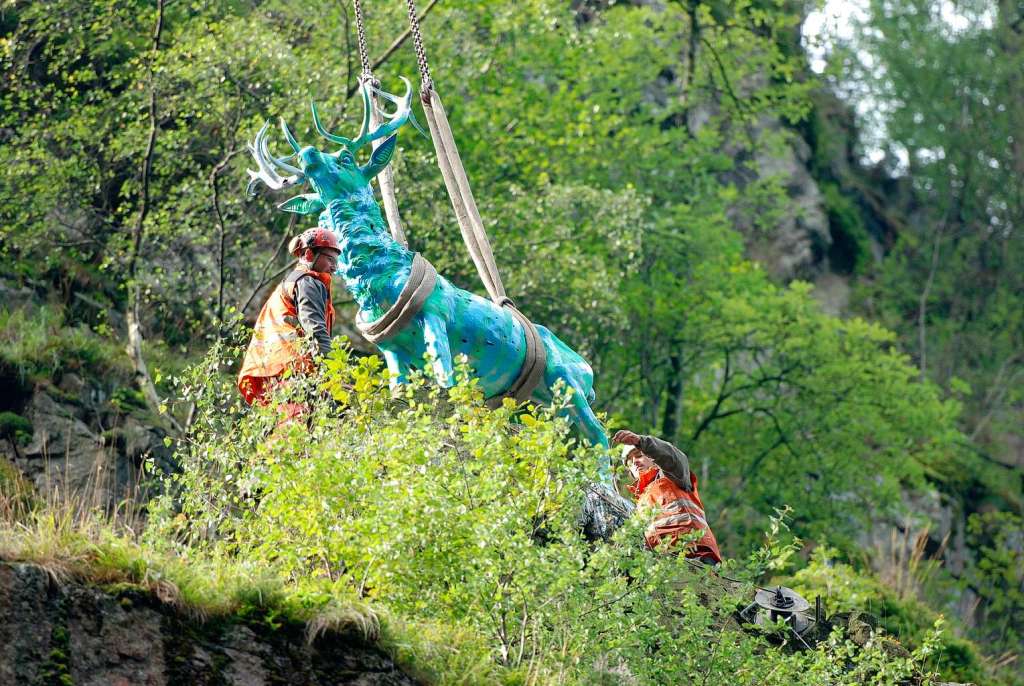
[[248, 79, 413, 214]]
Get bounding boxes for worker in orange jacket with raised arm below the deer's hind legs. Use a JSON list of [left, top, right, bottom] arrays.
[[611, 429, 722, 565]]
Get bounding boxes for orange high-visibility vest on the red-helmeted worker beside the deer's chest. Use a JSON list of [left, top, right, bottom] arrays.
[[239, 265, 334, 404]]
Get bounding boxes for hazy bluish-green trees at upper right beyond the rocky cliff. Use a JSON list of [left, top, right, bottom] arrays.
[[833, 0, 1024, 473]]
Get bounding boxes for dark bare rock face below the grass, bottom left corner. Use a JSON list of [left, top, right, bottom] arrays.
[[0, 563, 417, 686]]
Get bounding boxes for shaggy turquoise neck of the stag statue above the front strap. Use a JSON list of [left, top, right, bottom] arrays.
[[319, 185, 413, 319]]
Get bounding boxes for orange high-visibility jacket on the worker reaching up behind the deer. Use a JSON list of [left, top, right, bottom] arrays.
[[630, 467, 722, 562]]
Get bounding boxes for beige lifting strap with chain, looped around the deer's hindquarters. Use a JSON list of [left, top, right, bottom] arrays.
[[406, 0, 547, 406]]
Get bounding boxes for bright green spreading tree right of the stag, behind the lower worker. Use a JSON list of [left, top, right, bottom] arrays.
[[631, 262, 961, 543]]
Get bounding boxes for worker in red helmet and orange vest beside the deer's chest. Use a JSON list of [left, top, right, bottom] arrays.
[[238, 228, 341, 422]]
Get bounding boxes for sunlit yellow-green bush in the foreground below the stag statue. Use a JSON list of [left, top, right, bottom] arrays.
[[147, 346, 954, 684]]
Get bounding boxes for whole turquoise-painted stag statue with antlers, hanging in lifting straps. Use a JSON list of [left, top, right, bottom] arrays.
[[249, 84, 612, 486]]
